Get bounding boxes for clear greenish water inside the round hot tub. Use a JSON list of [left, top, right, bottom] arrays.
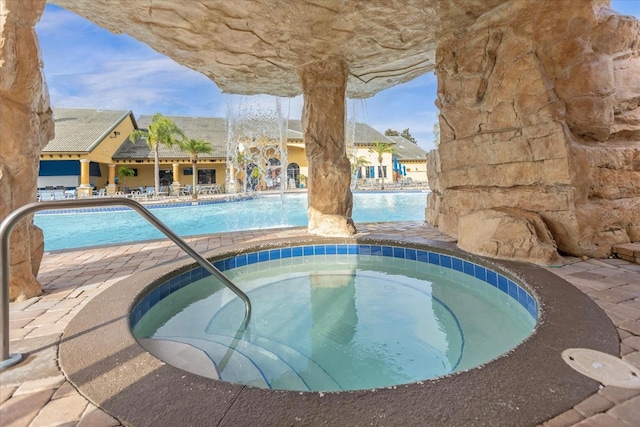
[[133, 255, 535, 391]]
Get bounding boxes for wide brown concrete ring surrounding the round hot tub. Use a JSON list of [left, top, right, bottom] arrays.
[[59, 232, 619, 426]]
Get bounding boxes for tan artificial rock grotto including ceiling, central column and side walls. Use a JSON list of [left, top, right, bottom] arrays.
[[0, 0, 640, 295]]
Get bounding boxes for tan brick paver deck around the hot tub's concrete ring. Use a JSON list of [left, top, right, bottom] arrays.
[[0, 222, 640, 427]]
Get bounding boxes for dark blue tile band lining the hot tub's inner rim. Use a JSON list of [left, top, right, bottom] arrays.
[[130, 243, 538, 327]]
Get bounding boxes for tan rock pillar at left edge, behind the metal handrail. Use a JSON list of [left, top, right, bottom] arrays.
[[0, 0, 53, 300]]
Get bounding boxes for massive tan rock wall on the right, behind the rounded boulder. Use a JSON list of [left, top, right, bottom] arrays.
[[427, 0, 640, 257]]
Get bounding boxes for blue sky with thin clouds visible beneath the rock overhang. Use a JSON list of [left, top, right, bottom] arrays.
[[36, 0, 640, 151]]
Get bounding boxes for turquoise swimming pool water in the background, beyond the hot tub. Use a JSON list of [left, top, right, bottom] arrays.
[[34, 193, 427, 251]]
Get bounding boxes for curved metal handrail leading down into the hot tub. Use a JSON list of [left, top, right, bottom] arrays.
[[0, 197, 251, 371]]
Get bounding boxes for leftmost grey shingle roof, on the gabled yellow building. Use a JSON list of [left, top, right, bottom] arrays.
[[42, 108, 135, 153]]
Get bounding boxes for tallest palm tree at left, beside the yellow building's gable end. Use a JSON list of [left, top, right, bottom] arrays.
[[129, 113, 184, 194]]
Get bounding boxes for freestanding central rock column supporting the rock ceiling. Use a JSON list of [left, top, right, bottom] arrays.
[[298, 58, 356, 236]]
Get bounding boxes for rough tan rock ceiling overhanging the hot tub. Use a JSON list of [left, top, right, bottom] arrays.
[[51, 0, 506, 98]]
